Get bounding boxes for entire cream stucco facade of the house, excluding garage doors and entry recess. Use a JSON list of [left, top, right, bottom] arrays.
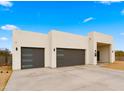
[[12, 30, 115, 70]]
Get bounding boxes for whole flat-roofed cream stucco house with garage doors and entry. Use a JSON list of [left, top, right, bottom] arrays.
[[12, 30, 115, 70]]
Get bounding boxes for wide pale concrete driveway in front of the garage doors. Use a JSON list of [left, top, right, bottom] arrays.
[[5, 65, 124, 91]]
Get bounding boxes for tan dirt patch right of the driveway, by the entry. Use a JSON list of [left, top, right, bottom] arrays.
[[102, 61, 124, 70]]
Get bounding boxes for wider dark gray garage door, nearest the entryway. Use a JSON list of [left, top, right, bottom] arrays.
[[57, 48, 85, 67]]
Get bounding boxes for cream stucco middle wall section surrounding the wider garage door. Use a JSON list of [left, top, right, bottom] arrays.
[[49, 30, 89, 68]]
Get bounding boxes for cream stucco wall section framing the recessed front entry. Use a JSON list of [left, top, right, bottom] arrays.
[[88, 32, 115, 64]]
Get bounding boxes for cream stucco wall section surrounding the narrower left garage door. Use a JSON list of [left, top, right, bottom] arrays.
[[12, 30, 50, 70]]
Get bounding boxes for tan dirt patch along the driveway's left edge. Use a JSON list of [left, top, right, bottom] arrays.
[[0, 66, 12, 91]]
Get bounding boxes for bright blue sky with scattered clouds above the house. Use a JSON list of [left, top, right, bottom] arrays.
[[0, 1, 124, 50]]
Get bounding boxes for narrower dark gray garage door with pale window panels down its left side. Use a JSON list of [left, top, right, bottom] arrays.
[[21, 47, 44, 69]]
